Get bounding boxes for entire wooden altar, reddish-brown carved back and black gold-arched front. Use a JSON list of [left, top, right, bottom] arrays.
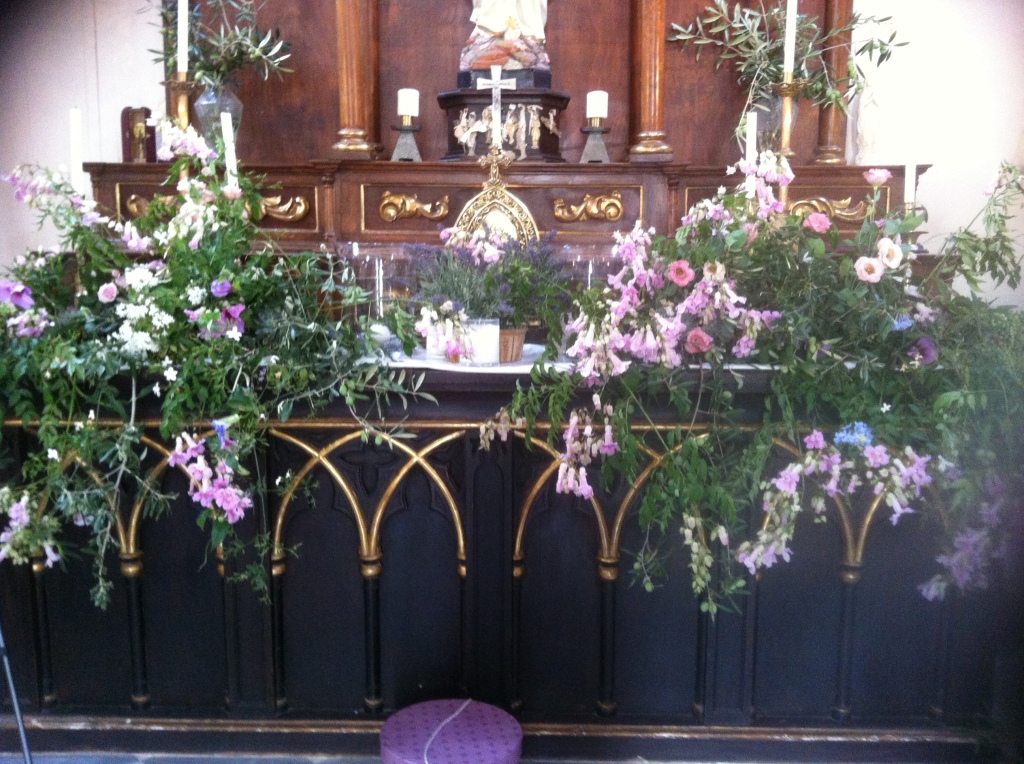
[[0, 0, 1019, 761]]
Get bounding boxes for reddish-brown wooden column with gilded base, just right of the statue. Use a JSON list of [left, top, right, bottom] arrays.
[[630, 0, 672, 162]]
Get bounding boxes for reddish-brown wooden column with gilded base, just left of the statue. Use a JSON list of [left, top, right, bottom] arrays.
[[333, 0, 377, 159]]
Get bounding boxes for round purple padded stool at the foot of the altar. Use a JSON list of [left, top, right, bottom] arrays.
[[381, 701, 522, 764]]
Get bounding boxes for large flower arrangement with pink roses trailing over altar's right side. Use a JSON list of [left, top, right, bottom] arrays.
[[481, 152, 1024, 613]]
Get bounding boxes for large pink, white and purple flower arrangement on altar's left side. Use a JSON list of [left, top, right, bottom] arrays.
[[0, 124, 418, 604]]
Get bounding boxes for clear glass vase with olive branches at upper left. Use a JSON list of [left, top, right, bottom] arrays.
[[160, 0, 291, 140]]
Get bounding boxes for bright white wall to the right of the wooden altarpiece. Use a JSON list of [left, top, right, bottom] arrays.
[[851, 0, 1024, 305]]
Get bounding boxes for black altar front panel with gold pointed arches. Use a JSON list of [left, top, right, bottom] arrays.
[[0, 375, 1020, 760]]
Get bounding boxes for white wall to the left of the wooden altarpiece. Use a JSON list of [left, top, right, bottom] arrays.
[[0, 0, 164, 260]]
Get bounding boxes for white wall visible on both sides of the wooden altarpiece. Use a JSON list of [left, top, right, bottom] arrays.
[[0, 0, 1024, 305]]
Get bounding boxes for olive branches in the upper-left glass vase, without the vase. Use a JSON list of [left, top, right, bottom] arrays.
[[159, 0, 291, 88]]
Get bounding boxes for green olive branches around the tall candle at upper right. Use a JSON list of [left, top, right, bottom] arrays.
[[669, 0, 906, 135]]
